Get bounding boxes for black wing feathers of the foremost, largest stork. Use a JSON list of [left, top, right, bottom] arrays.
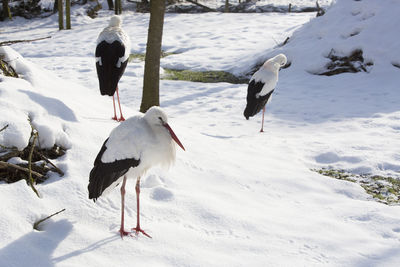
[[88, 138, 140, 201]]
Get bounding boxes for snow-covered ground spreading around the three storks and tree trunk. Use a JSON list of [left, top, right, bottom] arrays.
[[0, 0, 400, 266]]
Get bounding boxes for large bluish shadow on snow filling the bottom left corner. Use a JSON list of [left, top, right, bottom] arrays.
[[0, 219, 72, 267]]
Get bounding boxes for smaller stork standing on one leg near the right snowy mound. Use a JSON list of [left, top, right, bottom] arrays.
[[243, 54, 287, 132]]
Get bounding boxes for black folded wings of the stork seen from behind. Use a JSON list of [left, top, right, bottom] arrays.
[[96, 41, 128, 96]]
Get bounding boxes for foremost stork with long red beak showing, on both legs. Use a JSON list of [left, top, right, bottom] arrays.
[[88, 107, 185, 238]]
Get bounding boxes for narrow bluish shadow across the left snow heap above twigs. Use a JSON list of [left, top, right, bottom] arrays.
[[19, 90, 78, 122]]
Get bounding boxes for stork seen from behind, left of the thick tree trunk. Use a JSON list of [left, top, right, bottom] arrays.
[[96, 16, 130, 121]]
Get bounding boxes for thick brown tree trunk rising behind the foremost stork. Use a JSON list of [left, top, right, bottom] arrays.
[[140, 0, 165, 112]]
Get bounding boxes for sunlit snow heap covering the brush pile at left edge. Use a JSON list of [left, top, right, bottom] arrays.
[[0, 46, 72, 150]]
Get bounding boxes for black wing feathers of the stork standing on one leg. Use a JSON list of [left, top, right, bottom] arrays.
[[243, 80, 274, 120]]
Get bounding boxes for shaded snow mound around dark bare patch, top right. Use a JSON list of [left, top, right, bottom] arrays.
[[274, 0, 400, 73]]
